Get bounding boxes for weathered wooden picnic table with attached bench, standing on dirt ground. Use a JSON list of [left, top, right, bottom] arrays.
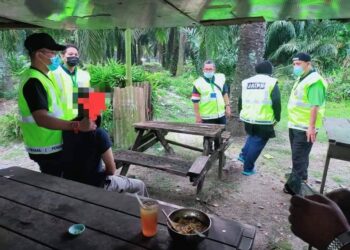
[[114, 121, 231, 193]]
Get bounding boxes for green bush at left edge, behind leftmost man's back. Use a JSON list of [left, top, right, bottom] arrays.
[[0, 113, 22, 144]]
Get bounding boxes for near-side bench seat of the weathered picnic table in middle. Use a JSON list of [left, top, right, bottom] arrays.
[[114, 150, 210, 193]]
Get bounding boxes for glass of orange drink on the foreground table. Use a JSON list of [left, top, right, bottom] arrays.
[[140, 200, 159, 237]]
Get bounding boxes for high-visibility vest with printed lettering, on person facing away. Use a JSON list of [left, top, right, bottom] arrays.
[[240, 74, 277, 125]]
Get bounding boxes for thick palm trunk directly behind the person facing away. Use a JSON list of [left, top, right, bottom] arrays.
[[227, 22, 266, 136]]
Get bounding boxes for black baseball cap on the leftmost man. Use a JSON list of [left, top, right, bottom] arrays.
[[24, 33, 66, 53]]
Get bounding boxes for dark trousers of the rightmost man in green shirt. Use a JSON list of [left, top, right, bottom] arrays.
[[289, 129, 313, 180]]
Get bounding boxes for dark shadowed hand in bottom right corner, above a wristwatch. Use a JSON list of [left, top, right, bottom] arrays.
[[288, 194, 350, 249]]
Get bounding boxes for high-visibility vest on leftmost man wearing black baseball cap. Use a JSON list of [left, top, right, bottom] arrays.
[[18, 69, 63, 154]]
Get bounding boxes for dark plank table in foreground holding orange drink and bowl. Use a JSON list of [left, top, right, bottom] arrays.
[[0, 167, 255, 250]]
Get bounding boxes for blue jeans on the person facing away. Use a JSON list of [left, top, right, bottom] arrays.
[[239, 135, 269, 172]]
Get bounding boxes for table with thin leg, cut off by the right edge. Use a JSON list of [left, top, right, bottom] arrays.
[[320, 118, 350, 194]]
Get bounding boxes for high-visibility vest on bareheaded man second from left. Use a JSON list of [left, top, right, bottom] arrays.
[[49, 66, 90, 120]]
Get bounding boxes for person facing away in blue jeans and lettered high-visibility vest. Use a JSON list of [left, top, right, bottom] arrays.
[[238, 61, 281, 176]]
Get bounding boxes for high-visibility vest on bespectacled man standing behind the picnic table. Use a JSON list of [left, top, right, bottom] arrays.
[[193, 74, 226, 119]]
